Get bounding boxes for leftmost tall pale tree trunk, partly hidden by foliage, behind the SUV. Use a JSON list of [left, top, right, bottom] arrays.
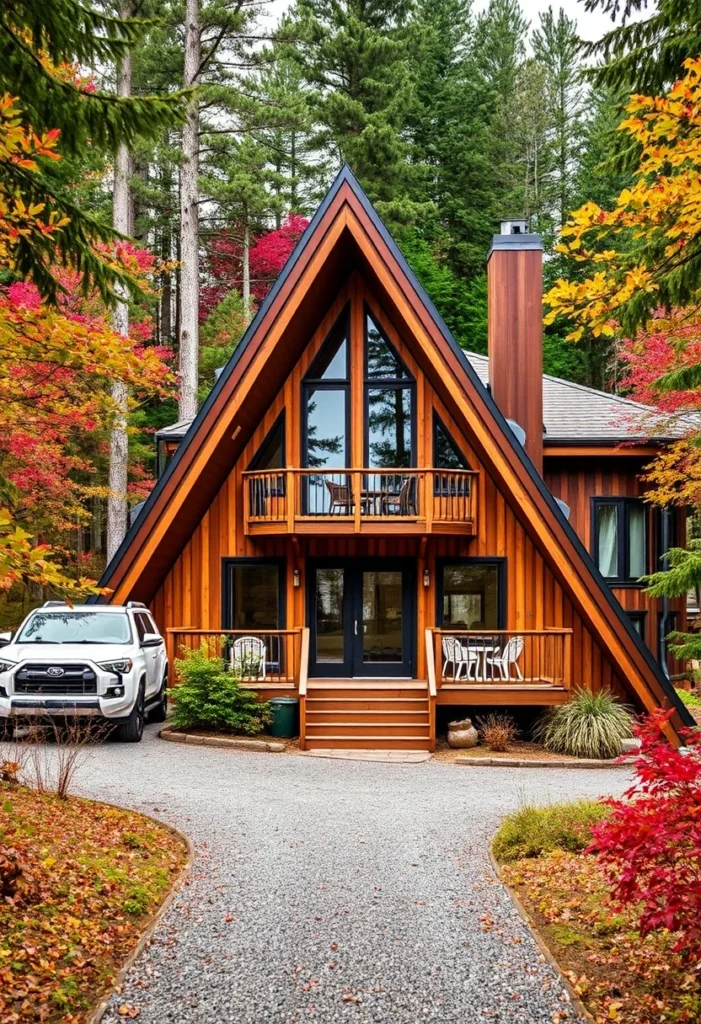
[[106, 0, 134, 561]]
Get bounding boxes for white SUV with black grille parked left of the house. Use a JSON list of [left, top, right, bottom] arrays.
[[0, 601, 168, 743]]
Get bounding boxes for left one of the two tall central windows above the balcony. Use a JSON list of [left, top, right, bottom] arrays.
[[302, 308, 350, 469]]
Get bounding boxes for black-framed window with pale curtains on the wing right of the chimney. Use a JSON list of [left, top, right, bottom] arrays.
[[593, 498, 648, 584]]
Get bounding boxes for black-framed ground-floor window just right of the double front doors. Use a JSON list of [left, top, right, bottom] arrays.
[[436, 558, 507, 630]]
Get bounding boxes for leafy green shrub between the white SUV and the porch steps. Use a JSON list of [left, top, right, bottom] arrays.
[[172, 641, 271, 733]]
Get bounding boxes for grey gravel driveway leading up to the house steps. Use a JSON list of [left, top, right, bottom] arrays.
[[56, 727, 627, 1024]]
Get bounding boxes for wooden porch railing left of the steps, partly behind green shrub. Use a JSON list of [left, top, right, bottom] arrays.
[[167, 626, 308, 688]]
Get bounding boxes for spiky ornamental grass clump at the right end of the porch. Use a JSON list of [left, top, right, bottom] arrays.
[[533, 689, 633, 758]]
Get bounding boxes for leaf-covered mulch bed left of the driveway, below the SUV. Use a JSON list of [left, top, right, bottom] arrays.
[[0, 782, 187, 1024]]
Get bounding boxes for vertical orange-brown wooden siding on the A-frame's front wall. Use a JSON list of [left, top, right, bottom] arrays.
[[151, 274, 654, 699]]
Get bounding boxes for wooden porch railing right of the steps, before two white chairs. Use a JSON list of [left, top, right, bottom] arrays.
[[427, 628, 572, 690]]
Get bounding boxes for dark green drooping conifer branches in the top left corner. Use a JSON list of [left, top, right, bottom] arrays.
[[0, 0, 182, 300]]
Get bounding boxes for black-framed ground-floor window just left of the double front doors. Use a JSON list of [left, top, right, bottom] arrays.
[[222, 558, 286, 633]]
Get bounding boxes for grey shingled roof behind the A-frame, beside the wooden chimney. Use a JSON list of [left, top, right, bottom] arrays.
[[156, 352, 681, 444]]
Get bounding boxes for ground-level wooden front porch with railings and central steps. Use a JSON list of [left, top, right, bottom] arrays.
[[168, 627, 572, 750]]
